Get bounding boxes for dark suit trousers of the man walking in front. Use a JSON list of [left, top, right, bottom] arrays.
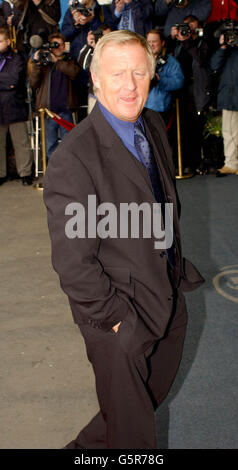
[[66, 294, 187, 449]]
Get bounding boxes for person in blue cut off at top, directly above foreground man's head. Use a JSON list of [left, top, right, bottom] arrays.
[[111, 0, 153, 36]]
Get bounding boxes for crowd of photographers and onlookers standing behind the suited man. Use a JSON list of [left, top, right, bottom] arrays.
[[0, 0, 238, 185]]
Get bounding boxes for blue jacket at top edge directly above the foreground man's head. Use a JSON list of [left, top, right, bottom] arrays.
[[111, 0, 153, 36]]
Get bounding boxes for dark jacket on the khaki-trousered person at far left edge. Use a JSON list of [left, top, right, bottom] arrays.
[[0, 48, 28, 124]]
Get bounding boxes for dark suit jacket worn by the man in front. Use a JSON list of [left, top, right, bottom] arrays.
[[44, 104, 202, 352]]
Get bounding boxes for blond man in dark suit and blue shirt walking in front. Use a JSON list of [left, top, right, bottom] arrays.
[[44, 31, 203, 449]]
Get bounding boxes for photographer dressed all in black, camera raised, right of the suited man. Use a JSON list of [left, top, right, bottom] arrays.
[[171, 15, 212, 174]]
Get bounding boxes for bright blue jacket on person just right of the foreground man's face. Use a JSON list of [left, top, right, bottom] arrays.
[[145, 55, 184, 112]]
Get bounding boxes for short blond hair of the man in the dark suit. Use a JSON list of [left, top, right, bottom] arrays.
[[90, 30, 155, 79]]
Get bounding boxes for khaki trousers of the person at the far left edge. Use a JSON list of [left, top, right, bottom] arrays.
[[0, 122, 32, 178]]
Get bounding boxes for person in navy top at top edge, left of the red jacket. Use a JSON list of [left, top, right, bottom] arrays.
[[155, 0, 211, 38]]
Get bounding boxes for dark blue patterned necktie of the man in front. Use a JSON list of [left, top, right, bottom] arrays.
[[134, 121, 174, 267]]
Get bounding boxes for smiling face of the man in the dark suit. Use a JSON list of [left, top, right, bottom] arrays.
[[92, 43, 150, 122]]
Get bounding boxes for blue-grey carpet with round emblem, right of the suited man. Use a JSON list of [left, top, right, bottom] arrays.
[[157, 175, 238, 449]]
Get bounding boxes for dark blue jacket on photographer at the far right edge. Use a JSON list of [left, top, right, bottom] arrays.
[[211, 46, 238, 111]]
